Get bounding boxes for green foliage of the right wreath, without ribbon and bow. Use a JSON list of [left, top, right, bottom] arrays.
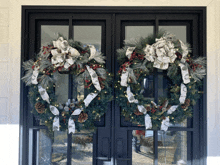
[[114, 31, 205, 129]]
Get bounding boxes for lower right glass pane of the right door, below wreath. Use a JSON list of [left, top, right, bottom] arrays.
[[158, 131, 187, 165]]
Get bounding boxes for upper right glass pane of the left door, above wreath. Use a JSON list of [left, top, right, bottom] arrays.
[[73, 25, 102, 52]]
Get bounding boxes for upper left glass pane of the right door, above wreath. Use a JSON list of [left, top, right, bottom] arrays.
[[125, 26, 154, 40]]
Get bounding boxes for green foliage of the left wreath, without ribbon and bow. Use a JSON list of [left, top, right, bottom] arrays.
[[23, 37, 113, 135]]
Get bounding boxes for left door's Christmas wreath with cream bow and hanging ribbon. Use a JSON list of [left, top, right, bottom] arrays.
[[22, 37, 112, 133]]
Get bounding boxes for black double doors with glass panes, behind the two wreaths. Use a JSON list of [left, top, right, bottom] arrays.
[[20, 6, 206, 165]]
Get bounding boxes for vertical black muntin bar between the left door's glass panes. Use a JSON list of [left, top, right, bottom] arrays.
[[67, 16, 73, 165]]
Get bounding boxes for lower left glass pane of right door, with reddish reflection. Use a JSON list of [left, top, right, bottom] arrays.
[[132, 130, 154, 165]]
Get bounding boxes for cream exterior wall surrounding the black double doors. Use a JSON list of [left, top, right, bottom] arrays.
[[0, 0, 220, 165]]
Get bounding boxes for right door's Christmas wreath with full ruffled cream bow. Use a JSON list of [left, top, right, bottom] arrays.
[[115, 32, 206, 131]]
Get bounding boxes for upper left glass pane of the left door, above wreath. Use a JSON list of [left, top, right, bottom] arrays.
[[41, 25, 69, 46]]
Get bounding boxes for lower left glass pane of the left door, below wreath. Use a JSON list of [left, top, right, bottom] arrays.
[[36, 130, 67, 165]]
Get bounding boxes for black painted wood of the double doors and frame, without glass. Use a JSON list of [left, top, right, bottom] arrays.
[[20, 6, 207, 165]]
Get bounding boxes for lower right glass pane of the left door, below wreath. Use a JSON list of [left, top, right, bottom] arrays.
[[71, 130, 93, 165]]
